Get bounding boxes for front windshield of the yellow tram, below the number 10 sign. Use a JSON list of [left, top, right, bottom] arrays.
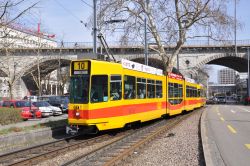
[[70, 75, 89, 104]]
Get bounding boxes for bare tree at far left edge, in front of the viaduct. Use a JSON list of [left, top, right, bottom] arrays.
[[0, 0, 37, 99]]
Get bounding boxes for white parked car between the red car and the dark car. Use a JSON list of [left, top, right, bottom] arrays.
[[33, 101, 62, 117]]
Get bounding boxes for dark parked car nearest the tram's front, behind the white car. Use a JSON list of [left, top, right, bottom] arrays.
[[39, 96, 69, 113]]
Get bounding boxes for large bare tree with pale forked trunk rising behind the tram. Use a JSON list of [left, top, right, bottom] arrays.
[[98, 0, 233, 72]]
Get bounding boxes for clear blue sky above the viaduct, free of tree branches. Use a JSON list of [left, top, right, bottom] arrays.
[[20, 0, 250, 42]]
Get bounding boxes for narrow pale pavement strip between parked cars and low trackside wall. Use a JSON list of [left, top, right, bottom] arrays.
[[0, 114, 68, 130]]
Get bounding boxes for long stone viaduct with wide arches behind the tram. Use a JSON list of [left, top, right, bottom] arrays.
[[0, 44, 250, 97]]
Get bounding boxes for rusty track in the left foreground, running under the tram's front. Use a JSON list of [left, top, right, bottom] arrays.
[[0, 134, 117, 166]]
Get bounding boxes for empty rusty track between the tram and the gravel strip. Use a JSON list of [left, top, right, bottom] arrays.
[[63, 110, 201, 166]]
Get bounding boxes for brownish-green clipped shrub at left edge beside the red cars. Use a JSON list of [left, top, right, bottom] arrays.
[[0, 108, 23, 125]]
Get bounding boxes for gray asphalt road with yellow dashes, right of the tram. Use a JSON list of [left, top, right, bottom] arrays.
[[201, 105, 250, 166]]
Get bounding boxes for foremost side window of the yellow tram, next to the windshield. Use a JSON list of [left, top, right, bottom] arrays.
[[90, 75, 108, 103]]
